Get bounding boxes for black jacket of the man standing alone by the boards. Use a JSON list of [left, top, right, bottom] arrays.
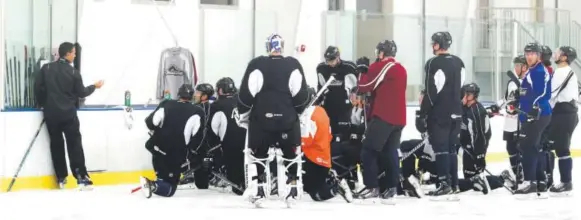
[[34, 59, 95, 120]]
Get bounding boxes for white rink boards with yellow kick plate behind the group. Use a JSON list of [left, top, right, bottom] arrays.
[[0, 107, 581, 192]]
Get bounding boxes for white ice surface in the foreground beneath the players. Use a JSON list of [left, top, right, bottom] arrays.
[[0, 159, 581, 220]]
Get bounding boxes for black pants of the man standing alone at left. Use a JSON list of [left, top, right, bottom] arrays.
[[45, 116, 88, 179]]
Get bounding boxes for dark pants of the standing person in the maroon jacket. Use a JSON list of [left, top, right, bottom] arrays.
[[361, 117, 403, 189]]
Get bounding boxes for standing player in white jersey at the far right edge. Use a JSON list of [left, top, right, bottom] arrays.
[[549, 46, 579, 193]]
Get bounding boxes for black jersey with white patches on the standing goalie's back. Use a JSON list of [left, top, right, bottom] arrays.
[[237, 56, 309, 131]]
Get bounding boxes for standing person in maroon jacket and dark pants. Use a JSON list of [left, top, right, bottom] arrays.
[[356, 40, 407, 203]]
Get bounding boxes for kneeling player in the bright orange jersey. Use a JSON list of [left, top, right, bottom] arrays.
[[301, 88, 353, 202]]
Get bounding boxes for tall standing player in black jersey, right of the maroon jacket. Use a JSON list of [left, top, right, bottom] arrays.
[[418, 32, 465, 196]]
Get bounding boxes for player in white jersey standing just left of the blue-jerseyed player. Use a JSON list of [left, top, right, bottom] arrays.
[[490, 55, 528, 184]]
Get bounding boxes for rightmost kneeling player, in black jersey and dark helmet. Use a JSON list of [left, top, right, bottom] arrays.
[[453, 83, 509, 194]]
